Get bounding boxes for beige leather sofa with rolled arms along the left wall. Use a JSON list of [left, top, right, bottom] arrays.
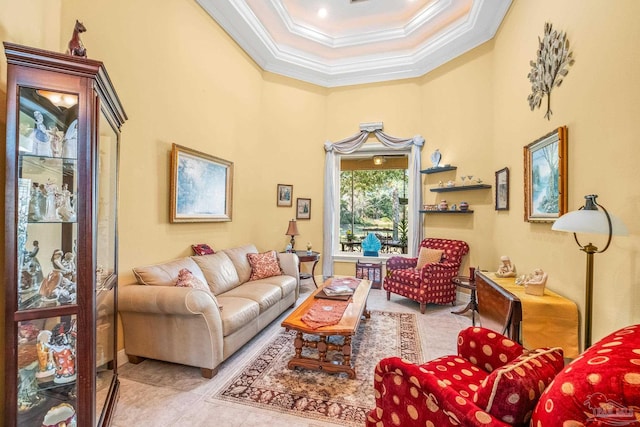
[[118, 245, 300, 378]]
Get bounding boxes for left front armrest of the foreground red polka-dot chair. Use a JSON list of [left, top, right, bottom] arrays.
[[367, 357, 509, 427]]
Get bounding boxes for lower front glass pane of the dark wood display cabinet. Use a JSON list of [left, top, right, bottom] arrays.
[[17, 315, 77, 426]]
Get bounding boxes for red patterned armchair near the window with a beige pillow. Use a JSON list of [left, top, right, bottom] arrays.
[[384, 238, 469, 314]]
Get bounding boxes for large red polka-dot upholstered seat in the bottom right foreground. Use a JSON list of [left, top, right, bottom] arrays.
[[366, 325, 640, 427]]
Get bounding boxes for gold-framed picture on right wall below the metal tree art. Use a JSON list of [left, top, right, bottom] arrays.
[[524, 126, 567, 222]]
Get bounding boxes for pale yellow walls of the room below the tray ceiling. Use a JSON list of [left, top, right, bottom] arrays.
[[0, 0, 640, 408]]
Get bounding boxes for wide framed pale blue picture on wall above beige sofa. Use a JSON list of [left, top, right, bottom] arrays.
[[170, 144, 233, 223]]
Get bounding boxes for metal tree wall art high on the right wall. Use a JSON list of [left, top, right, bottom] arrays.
[[527, 22, 574, 120]]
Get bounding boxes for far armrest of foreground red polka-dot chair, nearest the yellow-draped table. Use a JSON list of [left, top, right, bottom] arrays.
[[458, 326, 524, 372]]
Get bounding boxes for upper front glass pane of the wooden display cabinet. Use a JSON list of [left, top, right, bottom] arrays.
[[17, 87, 78, 310]]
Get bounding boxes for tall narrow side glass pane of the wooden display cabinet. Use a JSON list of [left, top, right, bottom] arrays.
[[96, 108, 118, 419]]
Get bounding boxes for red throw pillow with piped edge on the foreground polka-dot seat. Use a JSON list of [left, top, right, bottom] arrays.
[[473, 347, 564, 425]]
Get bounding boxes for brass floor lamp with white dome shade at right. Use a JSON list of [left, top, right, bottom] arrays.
[[551, 194, 629, 350]]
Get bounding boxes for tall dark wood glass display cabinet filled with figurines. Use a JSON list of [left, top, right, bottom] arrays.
[[4, 42, 126, 427]]
